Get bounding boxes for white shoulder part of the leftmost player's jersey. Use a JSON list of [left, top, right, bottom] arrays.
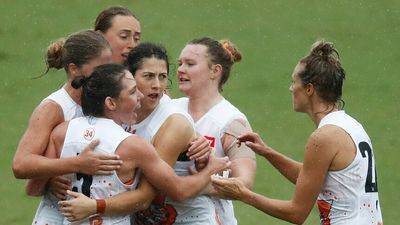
[[42, 88, 83, 121]]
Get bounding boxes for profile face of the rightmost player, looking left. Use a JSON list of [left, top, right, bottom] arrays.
[[289, 63, 308, 112]]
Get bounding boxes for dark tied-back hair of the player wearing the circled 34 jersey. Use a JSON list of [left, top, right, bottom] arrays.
[[72, 64, 127, 117]]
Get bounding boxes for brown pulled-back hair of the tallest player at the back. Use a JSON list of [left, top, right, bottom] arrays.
[[94, 6, 139, 33]]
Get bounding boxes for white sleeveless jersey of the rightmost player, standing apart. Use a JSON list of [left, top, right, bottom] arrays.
[[317, 111, 383, 225]]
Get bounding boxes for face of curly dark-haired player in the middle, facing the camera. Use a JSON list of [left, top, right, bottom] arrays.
[[135, 57, 168, 114]]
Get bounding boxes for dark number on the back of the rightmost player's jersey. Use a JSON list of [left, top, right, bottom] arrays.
[[358, 141, 378, 192]]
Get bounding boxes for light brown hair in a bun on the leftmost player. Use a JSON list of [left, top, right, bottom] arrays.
[[45, 30, 110, 74]]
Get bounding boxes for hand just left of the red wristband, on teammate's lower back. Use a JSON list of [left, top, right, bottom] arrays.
[[58, 191, 97, 222]]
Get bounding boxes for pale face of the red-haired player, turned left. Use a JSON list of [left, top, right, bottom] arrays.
[[177, 44, 218, 97]]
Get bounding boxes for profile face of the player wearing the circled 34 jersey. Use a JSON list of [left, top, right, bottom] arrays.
[[113, 70, 143, 125]]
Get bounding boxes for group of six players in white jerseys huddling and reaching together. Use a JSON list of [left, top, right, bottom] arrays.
[[13, 7, 383, 225]]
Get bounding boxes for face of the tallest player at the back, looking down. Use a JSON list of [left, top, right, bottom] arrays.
[[103, 15, 140, 64]]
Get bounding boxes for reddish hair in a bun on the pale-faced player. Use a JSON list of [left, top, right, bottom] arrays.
[[188, 37, 242, 92]]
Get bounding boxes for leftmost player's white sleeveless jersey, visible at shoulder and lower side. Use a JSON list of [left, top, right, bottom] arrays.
[[32, 88, 83, 225]]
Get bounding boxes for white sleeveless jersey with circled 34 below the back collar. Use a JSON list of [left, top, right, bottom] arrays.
[[60, 117, 140, 224]]
